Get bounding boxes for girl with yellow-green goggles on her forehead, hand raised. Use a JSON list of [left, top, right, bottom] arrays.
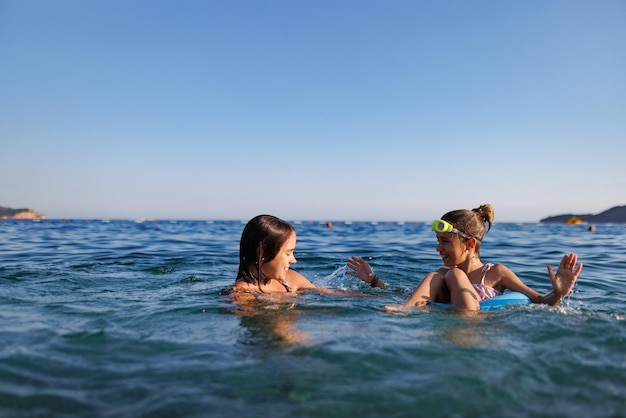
[[348, 204, 583, 311]]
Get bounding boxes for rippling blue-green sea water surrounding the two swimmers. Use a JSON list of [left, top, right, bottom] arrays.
[[0, 220, 626, 418]]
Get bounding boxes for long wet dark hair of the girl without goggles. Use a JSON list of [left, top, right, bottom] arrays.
[[236, 215, 295, 289]]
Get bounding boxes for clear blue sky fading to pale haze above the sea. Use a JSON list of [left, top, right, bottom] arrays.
[[0, 0, 626, 222]]
